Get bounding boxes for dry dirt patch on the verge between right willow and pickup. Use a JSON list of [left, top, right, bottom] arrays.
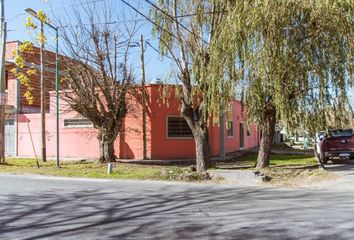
[[262, 167, 338, 187]]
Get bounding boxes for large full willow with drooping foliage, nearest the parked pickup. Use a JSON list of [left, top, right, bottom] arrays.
[[220, 0, 354, 168]]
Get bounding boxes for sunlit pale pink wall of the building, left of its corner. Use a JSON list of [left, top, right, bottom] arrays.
[[18, 92, 151, 159]]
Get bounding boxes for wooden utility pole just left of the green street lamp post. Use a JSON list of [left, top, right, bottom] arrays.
[[40, 21, 47, 162]]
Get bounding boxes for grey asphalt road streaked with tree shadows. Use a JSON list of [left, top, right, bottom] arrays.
[[0, 175, 354, 240]]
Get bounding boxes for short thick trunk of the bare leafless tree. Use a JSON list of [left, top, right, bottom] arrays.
[[98, 133, 116, 163]]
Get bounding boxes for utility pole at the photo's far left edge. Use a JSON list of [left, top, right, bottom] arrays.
[[0, 0, 7, 164]]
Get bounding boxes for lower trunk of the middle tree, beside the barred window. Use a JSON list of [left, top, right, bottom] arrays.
[[192, 127, 210, 176]]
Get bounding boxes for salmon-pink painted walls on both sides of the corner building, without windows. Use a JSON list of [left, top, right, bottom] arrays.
[[18, 85, 258, 159]]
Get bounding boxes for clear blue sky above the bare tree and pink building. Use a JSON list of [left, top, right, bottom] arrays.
[[5, 0, 171, 82]]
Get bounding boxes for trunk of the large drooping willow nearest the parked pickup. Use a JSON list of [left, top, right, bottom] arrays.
[[256, 101, 276, 169]]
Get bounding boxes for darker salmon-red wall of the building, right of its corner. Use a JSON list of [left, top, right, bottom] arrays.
[[150, 85, 258, 159]]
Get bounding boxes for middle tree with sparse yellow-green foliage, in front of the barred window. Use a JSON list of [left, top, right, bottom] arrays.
[[146, 0, 241, 174]]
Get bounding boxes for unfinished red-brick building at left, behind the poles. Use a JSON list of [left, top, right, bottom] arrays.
[[5, 41, 55, 155]]
